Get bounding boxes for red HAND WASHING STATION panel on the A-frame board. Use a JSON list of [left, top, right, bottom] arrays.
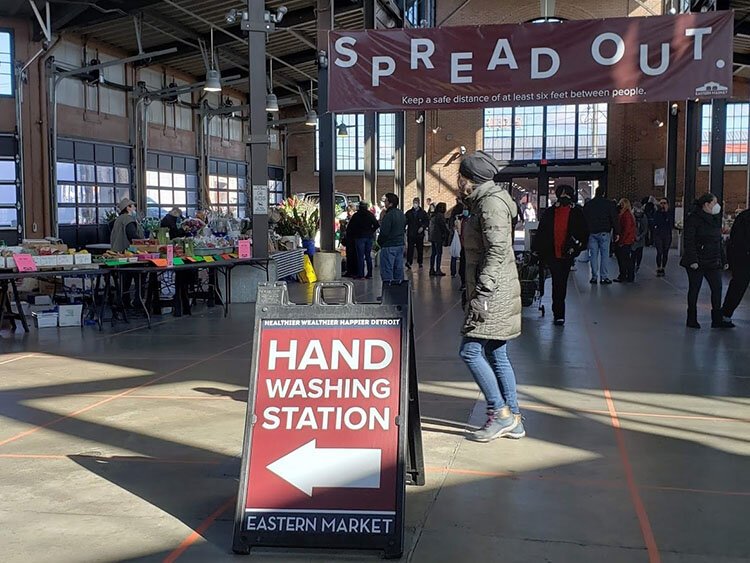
[[243, 319, 402, 535]]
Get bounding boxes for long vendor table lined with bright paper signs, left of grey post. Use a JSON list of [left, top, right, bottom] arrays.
[[102, 258, 270, 328]]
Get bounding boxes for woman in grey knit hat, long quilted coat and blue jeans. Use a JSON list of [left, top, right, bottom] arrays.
[[458, 151, 526, 442]]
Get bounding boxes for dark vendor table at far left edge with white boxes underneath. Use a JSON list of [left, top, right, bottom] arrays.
[[0, 265, 109, 332]]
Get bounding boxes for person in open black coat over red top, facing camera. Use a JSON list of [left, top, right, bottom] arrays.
[[532, 184, 589, 326]]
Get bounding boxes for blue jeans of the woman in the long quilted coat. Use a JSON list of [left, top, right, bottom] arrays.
[[459, 337, 521, 414]]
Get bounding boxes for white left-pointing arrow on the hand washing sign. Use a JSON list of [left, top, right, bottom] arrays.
[[268, 440, 382, 497]]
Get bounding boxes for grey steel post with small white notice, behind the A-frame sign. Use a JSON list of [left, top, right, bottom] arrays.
[[247, 0, 268, 258]]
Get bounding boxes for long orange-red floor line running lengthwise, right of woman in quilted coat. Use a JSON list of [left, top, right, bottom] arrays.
[[573, 277, 661, 563]]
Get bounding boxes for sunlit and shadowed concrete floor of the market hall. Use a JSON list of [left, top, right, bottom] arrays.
[[0, 250, 750, 563]]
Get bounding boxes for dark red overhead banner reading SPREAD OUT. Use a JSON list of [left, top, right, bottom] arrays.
[[328, 12, 734, 112]]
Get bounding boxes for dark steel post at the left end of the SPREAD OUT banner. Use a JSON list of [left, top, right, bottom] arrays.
[[317, 0, 336, 252]]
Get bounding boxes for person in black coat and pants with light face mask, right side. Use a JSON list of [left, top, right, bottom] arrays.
[[680, 193, 734, 328]]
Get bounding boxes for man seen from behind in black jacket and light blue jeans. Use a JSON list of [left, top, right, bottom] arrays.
[[583, 187, 620, 284]]
